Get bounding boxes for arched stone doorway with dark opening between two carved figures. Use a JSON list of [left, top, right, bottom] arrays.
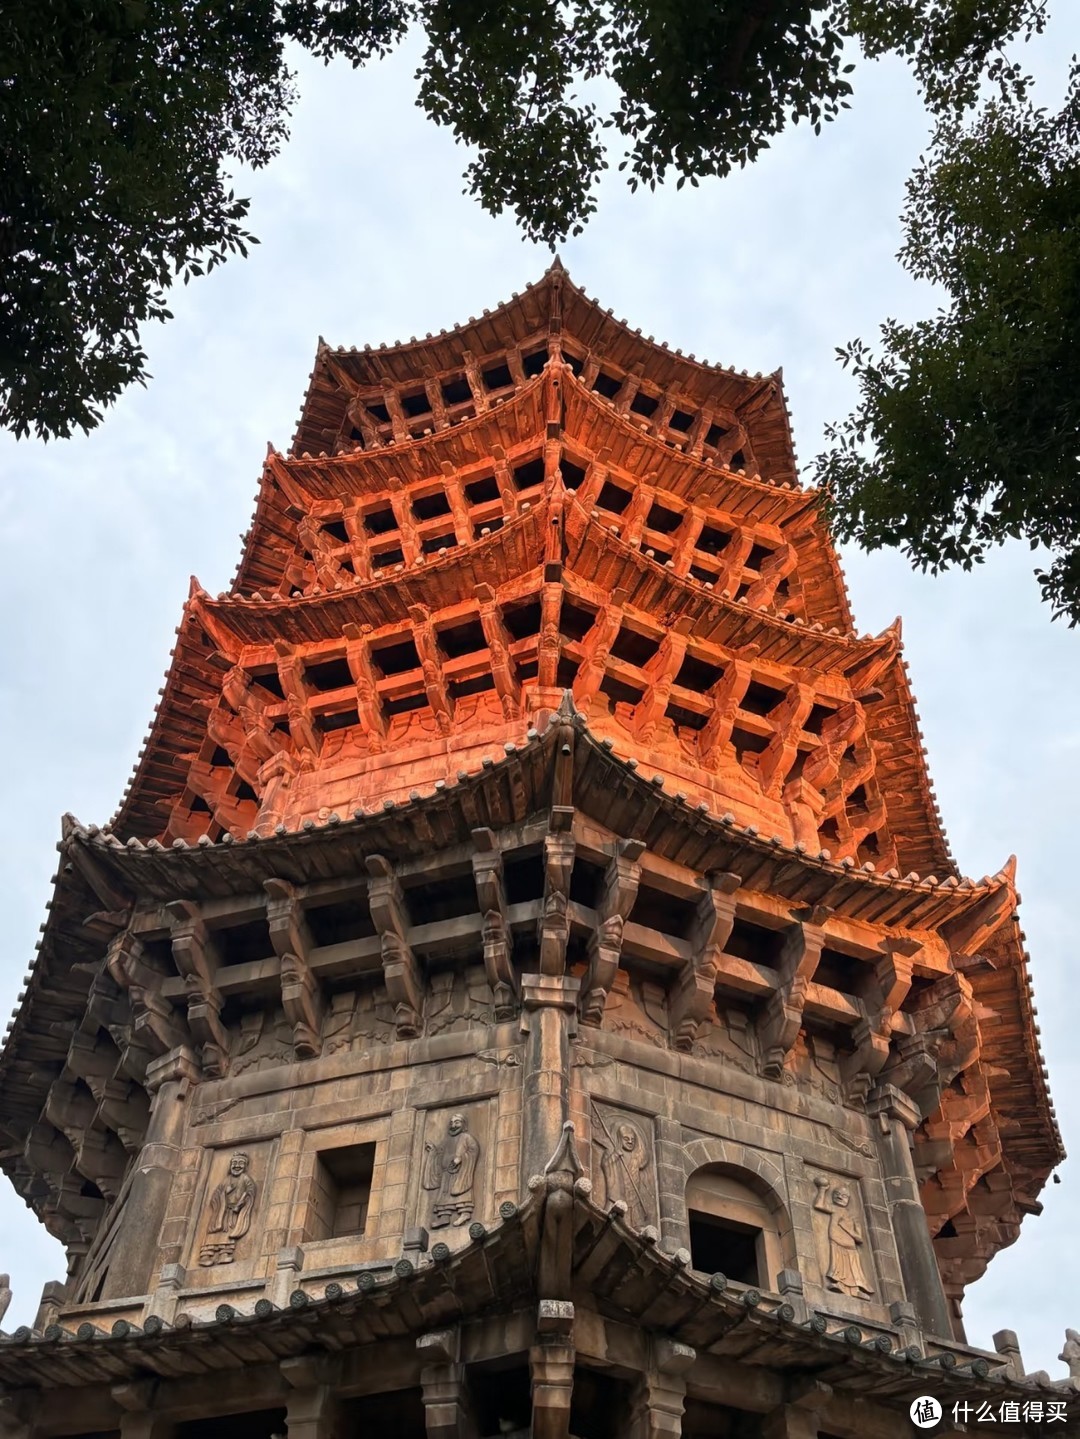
[[682, 1140, 797, 1292]]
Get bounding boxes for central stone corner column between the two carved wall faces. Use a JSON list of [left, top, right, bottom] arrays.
[[521, 974, 581, 1191]]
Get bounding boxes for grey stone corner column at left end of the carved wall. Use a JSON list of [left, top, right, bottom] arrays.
[[102, 1045, 200, 1299]]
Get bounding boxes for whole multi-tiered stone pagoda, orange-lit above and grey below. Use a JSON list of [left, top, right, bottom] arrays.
[[0, 263, 1080, 1439]]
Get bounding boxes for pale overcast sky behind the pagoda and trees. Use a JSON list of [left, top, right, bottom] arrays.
[[0, 14, 1080, 1376]]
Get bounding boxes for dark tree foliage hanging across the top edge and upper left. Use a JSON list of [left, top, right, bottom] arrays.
[[0, 0, 1064, 446]]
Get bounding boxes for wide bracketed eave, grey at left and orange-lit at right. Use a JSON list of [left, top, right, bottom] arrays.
[[0, 696, 1061, 1318]]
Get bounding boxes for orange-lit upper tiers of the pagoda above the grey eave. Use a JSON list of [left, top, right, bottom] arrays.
[[115, 271, 953, 875]]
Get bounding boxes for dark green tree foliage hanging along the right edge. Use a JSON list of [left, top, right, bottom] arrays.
[[818, 57, 1080, 625]]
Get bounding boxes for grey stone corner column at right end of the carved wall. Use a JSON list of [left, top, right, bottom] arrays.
[[866, 1085, 952, 1340]]
